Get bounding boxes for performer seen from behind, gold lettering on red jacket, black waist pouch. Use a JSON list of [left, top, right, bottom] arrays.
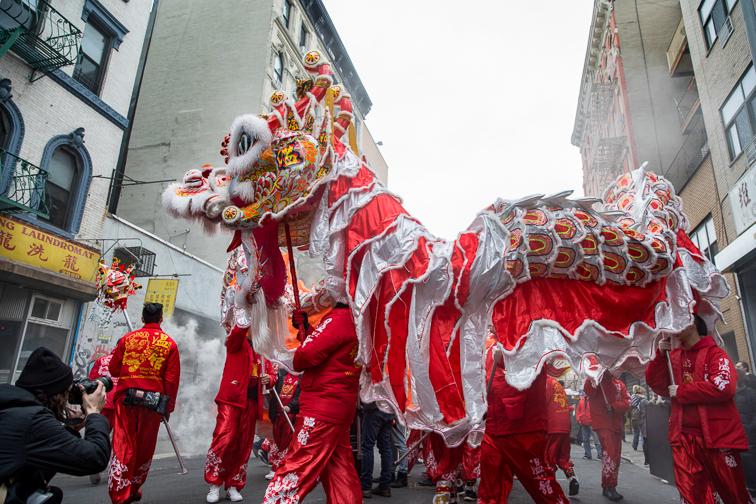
[[108, 303, 181, 504]]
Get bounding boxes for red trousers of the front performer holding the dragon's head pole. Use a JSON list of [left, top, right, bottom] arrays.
[[263, 415, 362, 504]]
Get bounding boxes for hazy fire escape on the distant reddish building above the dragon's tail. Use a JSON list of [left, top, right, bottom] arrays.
[[587, 82, 627, 190]]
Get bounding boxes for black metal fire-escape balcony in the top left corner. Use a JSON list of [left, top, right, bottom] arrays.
[[0, 0, 82, 72]]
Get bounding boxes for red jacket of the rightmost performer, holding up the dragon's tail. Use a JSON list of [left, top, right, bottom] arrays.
[[646, 336, 748, 450]]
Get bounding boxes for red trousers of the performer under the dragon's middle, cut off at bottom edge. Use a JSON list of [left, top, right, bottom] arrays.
[[478, 431, 569, 504]]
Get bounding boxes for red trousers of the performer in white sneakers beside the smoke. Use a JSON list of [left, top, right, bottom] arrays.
[[205, 400, 257, 490]]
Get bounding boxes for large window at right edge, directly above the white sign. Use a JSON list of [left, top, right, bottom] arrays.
[[721, 64, 756, 160]]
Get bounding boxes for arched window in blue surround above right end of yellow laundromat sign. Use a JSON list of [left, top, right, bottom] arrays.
[[40, 146, 81, 229]]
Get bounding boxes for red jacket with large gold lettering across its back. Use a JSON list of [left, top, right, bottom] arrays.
[[109, 324, 181, 412]]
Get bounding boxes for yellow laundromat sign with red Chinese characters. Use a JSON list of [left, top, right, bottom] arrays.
[[0, 216, 100, 282]]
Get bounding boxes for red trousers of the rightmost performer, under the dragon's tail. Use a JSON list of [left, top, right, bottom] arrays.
[[672, 432, 753, 504]]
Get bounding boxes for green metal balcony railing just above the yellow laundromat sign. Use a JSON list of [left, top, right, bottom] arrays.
[[0, 149, 50, 219]]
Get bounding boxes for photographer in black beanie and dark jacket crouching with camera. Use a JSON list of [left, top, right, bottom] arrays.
[[0, 347, 110, 504]]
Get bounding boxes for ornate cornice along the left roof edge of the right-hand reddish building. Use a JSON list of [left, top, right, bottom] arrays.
[[571, 0, 613, 147]]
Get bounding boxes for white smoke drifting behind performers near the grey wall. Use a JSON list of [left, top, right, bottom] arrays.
[[162, 319, 226, 456]]
